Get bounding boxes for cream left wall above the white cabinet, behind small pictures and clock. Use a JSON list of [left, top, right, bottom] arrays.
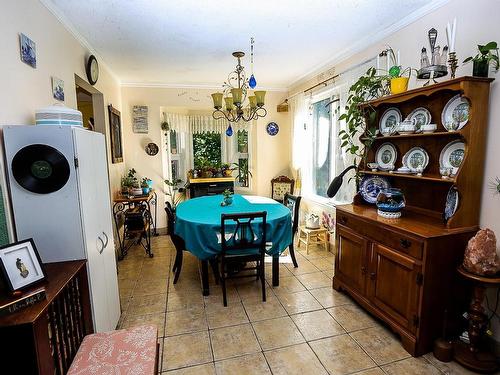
[[0, 0, 124, 239]]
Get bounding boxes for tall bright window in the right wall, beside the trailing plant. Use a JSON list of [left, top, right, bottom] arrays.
[[312, 98, 333, 198]]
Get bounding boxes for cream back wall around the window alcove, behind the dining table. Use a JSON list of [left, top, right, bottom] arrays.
[[122, 87, 290, 228]]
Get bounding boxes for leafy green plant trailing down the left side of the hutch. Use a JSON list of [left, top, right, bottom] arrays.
[[336, 67, 390, 165]]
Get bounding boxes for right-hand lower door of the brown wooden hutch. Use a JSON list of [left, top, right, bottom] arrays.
[[368, 243, 422, 332]]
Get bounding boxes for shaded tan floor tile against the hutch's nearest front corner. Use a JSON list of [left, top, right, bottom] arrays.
[[351, 326, 410, 365]]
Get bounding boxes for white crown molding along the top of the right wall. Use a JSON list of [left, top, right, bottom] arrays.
[[289, 0, 451, 89]]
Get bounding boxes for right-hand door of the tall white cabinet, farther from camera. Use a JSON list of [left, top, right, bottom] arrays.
[[94, 134, 121, 330]]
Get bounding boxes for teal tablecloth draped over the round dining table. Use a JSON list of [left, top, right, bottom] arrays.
[[175, 195, 292, 260]]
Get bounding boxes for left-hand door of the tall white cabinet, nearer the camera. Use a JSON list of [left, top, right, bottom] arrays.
[[73, 129, 110, 332]]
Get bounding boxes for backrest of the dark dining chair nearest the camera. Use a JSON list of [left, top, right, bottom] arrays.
[[221, 211, 267, 255]]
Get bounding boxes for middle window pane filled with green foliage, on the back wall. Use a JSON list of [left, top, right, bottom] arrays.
[[193, 132, 222, 168]]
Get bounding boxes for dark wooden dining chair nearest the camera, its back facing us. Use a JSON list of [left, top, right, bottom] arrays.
[[219, 211, 267, 306]]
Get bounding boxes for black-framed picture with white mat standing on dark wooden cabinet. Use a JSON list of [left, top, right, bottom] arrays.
[[0, 238, 46, 292]]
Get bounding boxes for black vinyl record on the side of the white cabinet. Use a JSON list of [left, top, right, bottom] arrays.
[[12, 144, 70, 194]]
